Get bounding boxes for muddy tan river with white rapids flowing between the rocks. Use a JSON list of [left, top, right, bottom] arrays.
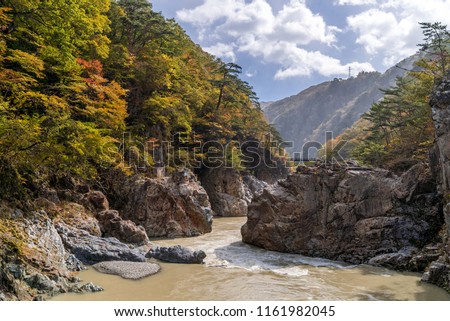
[[53, 218, 450, 301]]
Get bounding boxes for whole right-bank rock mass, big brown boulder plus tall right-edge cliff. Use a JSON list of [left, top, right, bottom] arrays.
[[242, 71, 450, 291]]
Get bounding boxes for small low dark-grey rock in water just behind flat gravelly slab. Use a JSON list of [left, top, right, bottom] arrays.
[[146, 245, 206, 264]]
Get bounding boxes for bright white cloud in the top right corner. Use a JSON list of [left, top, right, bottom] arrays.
[[348, 0, 450, 67]]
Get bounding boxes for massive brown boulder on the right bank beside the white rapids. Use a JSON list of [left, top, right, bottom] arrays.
[[241, 164, 442, 263]]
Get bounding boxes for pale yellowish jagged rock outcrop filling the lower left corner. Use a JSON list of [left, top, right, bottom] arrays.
[[0, 204, 100, 300]]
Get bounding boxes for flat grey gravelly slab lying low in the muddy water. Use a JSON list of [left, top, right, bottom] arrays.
[[93, 261, 161, 280]]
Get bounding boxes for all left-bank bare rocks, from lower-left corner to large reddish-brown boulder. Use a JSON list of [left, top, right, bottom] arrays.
[[0, 172, 212, 301]]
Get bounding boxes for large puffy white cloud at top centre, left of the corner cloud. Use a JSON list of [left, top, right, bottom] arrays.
[[177, 0, 373, 79]]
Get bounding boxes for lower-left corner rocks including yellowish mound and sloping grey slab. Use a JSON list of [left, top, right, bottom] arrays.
[[0, 198, 134, 301]]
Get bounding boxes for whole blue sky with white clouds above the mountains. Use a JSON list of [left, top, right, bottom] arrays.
[[150, 0, 450, 101]]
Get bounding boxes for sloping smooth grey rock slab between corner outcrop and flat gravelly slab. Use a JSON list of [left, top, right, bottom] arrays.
[[56, 222, 145, 265]]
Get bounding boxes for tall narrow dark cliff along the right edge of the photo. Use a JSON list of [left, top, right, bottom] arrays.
[[422, 74, 450, 292]]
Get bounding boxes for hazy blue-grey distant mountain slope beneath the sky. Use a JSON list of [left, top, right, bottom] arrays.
[[264, 56, 417, 157]]
